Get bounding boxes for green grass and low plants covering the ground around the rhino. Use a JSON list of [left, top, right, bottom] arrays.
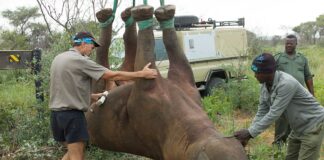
[[0, 46, 324, 160]]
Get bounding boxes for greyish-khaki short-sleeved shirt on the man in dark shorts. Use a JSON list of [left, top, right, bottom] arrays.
[[49, 48, 108, 111]]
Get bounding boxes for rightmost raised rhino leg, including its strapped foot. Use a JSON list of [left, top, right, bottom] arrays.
[[155, 5, 201, 104]]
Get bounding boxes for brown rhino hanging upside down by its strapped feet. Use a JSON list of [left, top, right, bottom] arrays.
[[86, 5, 247, 160]]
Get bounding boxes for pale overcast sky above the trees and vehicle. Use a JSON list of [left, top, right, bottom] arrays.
[[0, 0, 324, 36]]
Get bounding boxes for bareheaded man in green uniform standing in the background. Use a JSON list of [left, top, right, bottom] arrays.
[[274, 35, 314, 145]]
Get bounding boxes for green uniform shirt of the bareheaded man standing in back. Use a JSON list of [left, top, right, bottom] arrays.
[[274, 53, 313, 86]]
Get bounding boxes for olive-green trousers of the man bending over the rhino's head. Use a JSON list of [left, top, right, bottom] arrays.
[[286, 122, 324, 160]]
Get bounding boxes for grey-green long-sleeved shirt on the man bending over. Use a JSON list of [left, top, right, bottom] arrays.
[[248, 71, 324, 137]]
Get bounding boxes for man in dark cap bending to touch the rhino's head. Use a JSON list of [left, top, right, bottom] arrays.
[[234, 53, 324, 160]]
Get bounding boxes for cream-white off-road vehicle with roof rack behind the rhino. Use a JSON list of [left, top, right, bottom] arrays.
[[154, 16, 247, 96]]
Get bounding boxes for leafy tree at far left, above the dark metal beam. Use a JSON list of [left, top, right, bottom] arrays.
[[0, 7, 50, 50]]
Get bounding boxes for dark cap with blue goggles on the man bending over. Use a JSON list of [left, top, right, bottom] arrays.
[[251, 53, 276, 73]]
